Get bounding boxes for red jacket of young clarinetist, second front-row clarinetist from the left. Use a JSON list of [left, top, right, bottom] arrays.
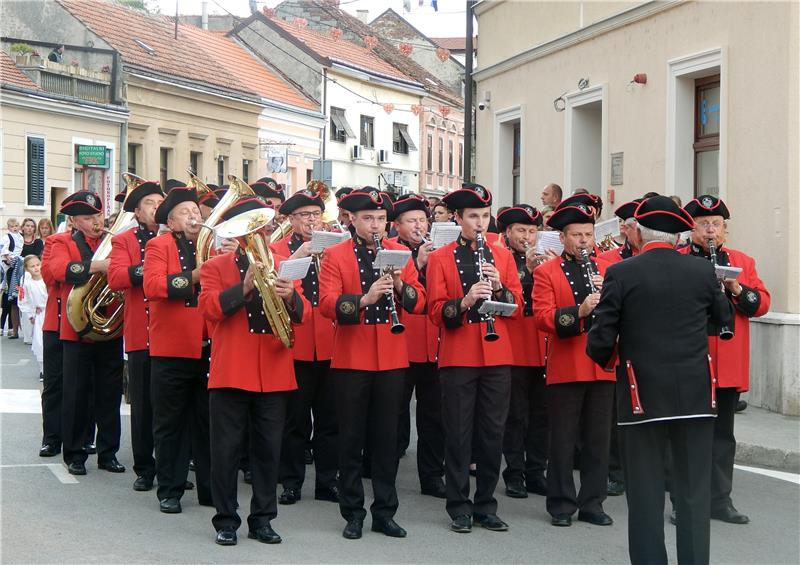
[[426, 238, 523, 367]]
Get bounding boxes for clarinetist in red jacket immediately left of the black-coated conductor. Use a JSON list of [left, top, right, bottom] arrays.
[[533, 204, 614, 526]]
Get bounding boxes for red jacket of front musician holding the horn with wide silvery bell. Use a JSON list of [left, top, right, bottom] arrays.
[[199, 251, 311, 392]]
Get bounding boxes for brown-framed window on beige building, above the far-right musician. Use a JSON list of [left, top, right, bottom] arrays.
[[693, 75, 721, 196]]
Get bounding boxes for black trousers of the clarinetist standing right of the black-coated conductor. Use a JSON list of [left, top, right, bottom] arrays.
[[711, 388, 739, 510]]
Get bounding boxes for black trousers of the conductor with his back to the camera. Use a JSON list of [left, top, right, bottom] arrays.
[[620, 418, 714, 565]]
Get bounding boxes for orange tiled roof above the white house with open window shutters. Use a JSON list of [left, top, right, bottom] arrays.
[[269, 18, 416, 82]]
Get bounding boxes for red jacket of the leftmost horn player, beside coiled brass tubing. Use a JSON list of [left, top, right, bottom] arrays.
[[48, 231, 104, 343]]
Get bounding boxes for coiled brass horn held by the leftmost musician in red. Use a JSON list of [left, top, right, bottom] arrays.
[[66, 173, 141, 341]]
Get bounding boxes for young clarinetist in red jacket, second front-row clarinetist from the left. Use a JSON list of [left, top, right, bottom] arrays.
[[426, 184, 523, 533]]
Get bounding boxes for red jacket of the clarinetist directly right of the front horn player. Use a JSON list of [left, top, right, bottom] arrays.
[[319, 238, 425, 371]]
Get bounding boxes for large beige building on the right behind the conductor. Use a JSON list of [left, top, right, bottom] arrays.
[[475, 0, 800, 414]]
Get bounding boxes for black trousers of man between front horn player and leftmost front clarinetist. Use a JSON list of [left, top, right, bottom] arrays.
[[279, 361, 339, 490]]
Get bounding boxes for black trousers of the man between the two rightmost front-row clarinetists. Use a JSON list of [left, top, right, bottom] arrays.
[[503, 367, 548, 483]]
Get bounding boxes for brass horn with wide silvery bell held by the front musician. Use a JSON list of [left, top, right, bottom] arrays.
[[216, 205, 294, 348]]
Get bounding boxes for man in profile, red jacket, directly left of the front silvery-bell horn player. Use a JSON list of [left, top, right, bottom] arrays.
[[143, 187, 212, 514]]
